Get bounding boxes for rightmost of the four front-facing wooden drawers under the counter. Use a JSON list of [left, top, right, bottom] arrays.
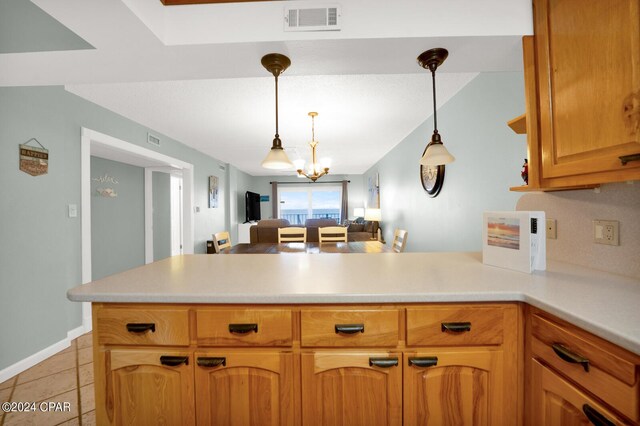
[[407, 306, 504, 346]]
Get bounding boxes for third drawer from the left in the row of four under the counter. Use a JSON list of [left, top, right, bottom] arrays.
[[300, 309, 399, 347]]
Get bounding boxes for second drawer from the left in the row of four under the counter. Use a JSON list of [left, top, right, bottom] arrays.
[[196, 308, 292, 346]]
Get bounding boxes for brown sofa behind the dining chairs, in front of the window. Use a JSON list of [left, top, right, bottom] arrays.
[[249, 219, 378, 244]]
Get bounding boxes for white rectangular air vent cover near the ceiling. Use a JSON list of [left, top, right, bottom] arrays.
[[284, 4, 341, 31]]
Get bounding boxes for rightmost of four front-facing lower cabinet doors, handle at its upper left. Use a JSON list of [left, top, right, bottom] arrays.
[[404, 350, 504, 426]]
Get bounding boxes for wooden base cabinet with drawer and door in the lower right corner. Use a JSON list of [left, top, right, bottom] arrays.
[[526, 308, 640, 426]]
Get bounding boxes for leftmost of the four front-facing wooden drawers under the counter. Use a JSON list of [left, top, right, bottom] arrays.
[[96, 308, 189, 346]]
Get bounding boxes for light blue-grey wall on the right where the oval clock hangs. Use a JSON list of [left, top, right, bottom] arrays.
[[363, 73, 526, 251]]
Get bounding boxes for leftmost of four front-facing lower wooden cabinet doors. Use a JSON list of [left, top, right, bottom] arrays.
[[105, 350, 195, 425]]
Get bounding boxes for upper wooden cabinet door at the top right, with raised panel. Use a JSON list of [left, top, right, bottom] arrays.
[[534, 0, 640, 183]]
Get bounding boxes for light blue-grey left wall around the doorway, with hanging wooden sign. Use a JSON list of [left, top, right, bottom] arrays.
[[0, 87, 228, 370]]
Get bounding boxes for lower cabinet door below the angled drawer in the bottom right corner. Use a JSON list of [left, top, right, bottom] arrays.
[[530, 360, 631, 426]]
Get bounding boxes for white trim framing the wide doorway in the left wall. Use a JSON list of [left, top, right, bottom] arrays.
[[80, 127, 194, 331]]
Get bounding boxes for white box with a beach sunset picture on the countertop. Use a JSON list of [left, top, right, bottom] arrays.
[[482, 211, 547, 273]]
